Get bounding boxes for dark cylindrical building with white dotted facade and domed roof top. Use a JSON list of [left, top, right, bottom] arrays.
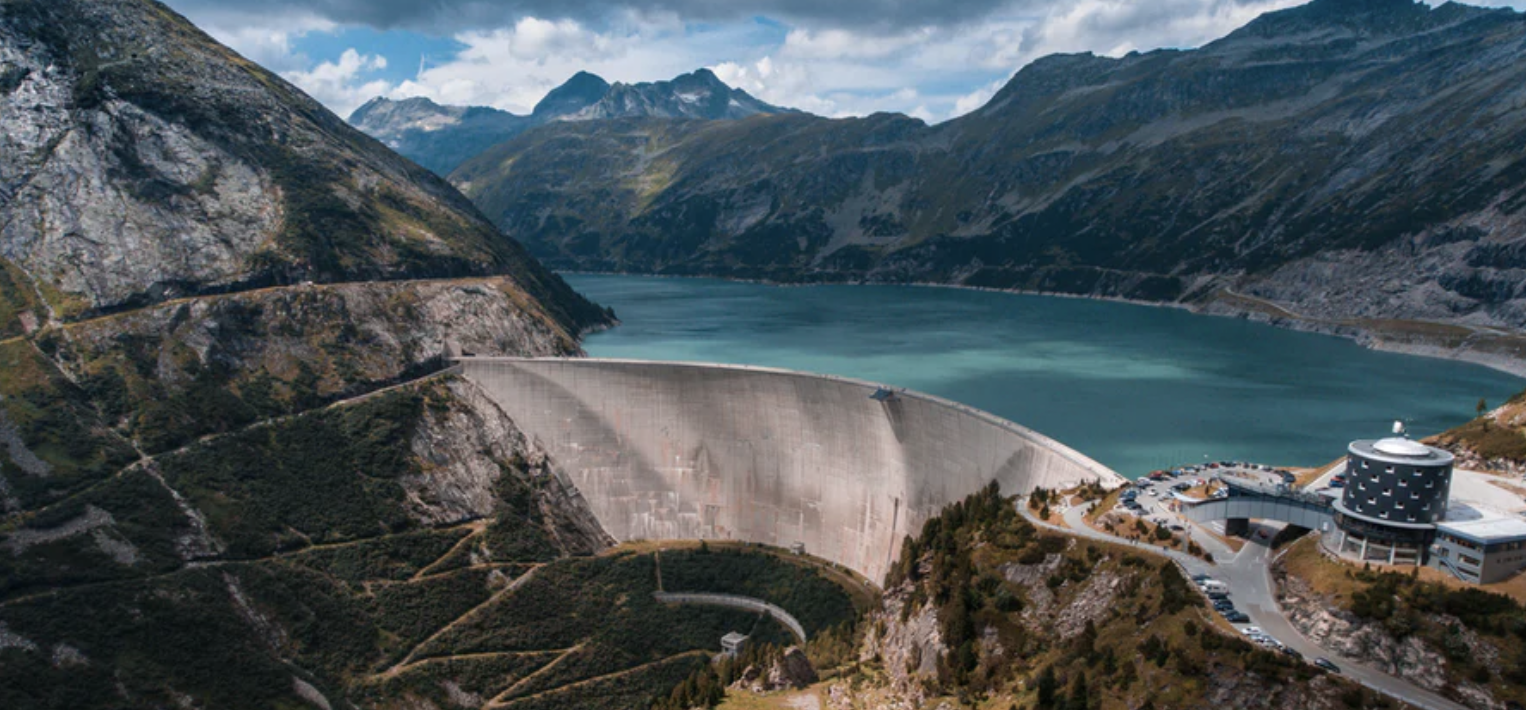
[[1322, 437, 1453, 565]]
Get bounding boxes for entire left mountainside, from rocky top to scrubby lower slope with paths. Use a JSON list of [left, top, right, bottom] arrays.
[[0, 0, 610, 708]]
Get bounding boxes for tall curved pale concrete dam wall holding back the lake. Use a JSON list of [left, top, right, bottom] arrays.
[[458, 357, 1126, 583]]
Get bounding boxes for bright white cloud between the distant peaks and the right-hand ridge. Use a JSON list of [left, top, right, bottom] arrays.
[[716, 0, 1302, 121]]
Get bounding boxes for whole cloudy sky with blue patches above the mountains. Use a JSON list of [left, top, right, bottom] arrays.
[[166, 0, 1526, 122]]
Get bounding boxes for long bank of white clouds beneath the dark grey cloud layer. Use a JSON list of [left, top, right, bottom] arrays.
[[187, 0, 1521, 121]]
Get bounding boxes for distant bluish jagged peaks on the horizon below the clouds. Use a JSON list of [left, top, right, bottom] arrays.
[[349, 69, 794, 176]]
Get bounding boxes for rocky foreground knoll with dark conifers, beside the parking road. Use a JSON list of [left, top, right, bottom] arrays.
[[848, 499, 1372, 710]]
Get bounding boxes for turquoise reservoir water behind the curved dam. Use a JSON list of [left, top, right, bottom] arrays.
[[566, 275, 1526, 478]]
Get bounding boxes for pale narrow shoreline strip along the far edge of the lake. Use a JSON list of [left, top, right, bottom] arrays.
[[555, 270, 1526, 379]]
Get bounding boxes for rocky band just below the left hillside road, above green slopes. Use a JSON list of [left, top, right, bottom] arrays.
[[55, 278, 580, 392]]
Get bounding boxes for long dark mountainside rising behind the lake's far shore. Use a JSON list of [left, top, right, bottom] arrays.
[[452, 0, 1526, 354]]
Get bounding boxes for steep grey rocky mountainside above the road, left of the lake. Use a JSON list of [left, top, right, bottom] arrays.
[[0, 0, 604, 325]]
